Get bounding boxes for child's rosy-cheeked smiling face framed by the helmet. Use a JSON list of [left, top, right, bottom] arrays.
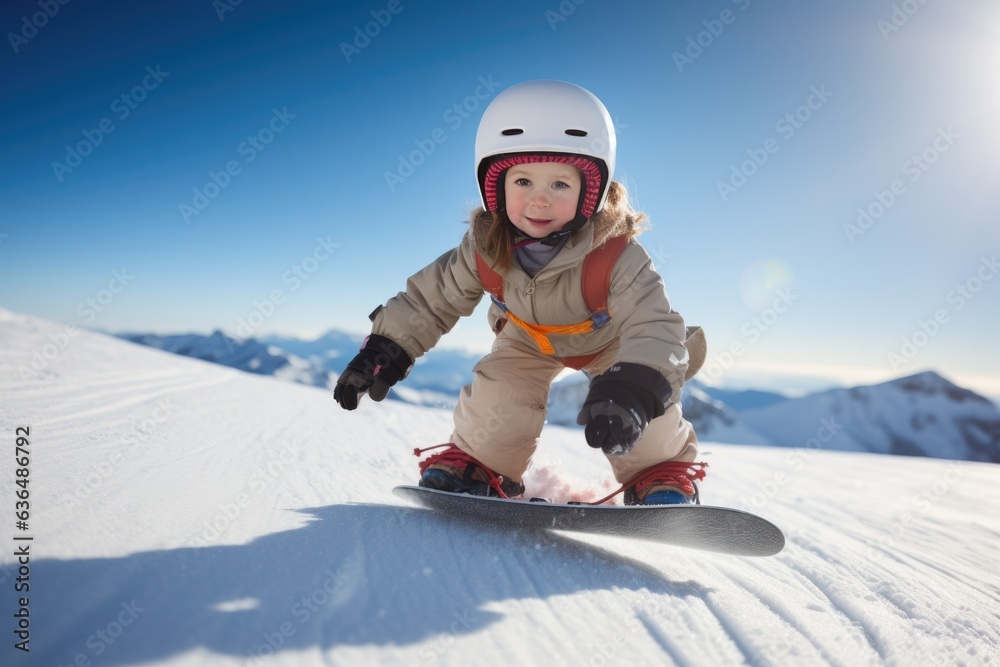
[[504, 162, 582, 239]]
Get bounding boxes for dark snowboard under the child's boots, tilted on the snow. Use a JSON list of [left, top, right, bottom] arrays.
[[392, 486, 785, 556]]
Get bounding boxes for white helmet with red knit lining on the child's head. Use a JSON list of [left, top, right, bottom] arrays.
[[476, 81, 616, 219]]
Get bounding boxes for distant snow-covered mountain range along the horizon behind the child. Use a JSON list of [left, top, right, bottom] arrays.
[[124, 331, 1000, 462]]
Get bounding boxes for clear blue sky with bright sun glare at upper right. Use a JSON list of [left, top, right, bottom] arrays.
[[0, 0, 1000, 396]]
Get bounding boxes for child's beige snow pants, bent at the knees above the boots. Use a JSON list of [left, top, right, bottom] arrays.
[[451, 333, 698, 484]]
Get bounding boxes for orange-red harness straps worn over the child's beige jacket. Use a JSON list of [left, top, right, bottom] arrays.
[[476, 236, 629, 370]]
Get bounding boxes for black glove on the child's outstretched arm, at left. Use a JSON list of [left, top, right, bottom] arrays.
[[333, 334, 413, 410]]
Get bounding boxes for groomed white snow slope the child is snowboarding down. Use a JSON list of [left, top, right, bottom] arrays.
[[0, 310, 1000, 666]]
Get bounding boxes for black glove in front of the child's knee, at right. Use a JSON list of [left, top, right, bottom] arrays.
[[576, 363, 671, 456]]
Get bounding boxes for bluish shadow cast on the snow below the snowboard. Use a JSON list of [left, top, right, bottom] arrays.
[[7, 504, 708, 665]]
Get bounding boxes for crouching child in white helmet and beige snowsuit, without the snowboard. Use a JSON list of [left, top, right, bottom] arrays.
[[334, 81, 705, 505]]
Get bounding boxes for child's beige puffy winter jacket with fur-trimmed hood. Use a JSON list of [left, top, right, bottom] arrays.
[[372, 208, 688, 402]]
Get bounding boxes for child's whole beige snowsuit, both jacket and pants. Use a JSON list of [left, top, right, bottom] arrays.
[[372, 208, 704, 483]]
